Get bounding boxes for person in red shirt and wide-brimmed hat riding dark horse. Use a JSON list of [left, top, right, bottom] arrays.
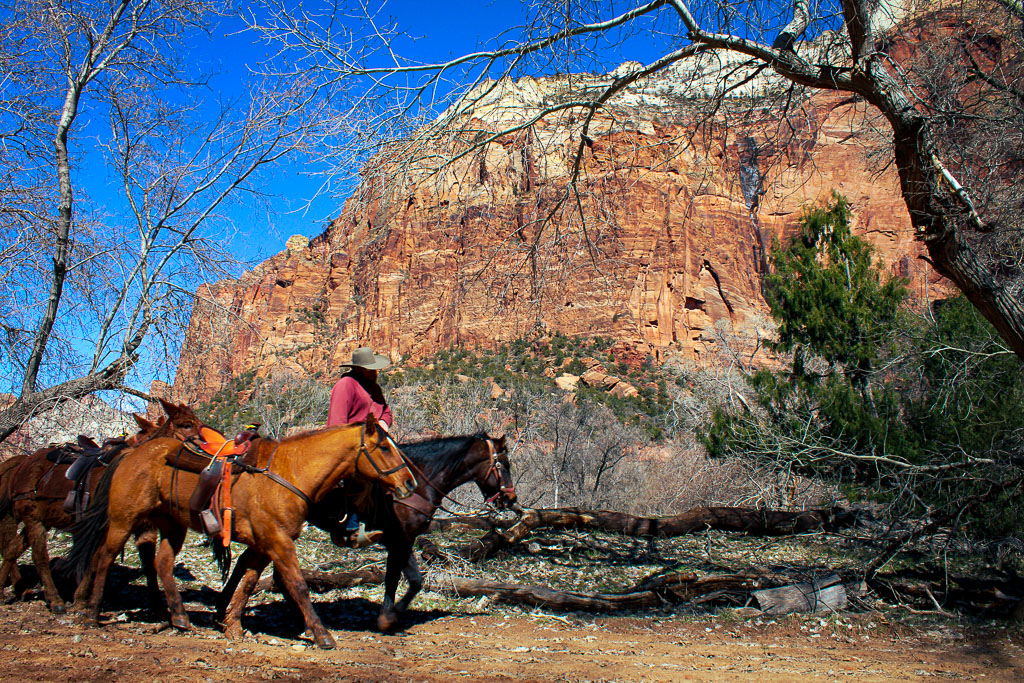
[[327, 346, 392, 548]]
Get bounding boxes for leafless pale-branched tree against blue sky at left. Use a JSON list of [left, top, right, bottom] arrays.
[[0, 0, 322, 439]]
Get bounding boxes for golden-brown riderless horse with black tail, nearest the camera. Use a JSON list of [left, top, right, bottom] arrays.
[[70, 417, 416, 648]]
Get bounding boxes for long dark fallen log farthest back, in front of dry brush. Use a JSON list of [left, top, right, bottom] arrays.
[[461, 508, 860, 561]]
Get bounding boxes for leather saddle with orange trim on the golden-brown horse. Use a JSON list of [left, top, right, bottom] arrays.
[[166, 424, 260, 548]]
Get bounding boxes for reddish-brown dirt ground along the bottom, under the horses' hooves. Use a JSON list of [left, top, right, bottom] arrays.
[[0, 594, 1024, 682]]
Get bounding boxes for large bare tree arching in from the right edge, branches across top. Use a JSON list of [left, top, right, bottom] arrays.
[[252, 0, 1024, 357]]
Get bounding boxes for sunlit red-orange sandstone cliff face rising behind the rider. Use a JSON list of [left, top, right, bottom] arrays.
[[174, 79, 944, 400]]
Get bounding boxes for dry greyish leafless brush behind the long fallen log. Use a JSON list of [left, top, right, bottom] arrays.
[[389, 374, 837, 515]]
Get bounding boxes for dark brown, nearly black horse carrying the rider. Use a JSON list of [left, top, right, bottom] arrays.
[[217, 433, 516, 637]]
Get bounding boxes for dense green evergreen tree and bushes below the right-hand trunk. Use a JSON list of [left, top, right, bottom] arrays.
[[706, 197, 1024, 538]]
